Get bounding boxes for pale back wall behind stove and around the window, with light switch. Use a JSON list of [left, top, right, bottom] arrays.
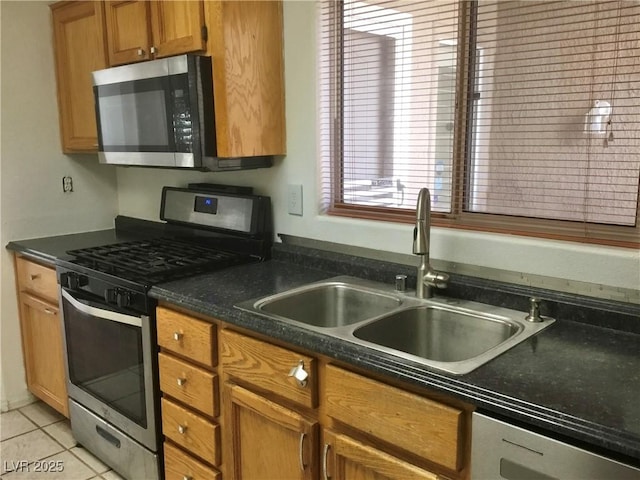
[[117, 1, 640, 290]]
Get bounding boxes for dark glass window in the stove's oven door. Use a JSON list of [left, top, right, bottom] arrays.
[[63, 299, 147, 428]]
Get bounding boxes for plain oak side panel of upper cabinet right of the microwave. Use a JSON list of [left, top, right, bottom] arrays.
[[205, 1, 286, 157]]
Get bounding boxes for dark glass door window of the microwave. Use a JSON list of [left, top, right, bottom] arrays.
[[94, 77, 175, 152]]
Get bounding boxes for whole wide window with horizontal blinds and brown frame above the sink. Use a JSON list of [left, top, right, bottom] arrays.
[[319, 0, 640, 246]]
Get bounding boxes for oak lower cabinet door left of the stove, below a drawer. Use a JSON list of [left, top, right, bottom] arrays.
[[20, 293, 69, 417]]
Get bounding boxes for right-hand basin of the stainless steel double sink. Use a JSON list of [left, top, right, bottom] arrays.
[[353, 306, 522, 362]]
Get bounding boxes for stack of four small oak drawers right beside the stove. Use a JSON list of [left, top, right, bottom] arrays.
[[156, 307, 222, 480]]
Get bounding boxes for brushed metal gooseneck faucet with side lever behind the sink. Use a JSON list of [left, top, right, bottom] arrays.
[[413, 188, 449, 298]]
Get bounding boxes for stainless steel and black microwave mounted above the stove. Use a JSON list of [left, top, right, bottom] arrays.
[[93, 55, 273, 171]]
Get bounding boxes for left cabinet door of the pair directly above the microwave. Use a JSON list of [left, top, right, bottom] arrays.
[[104, 0, 151, 66]]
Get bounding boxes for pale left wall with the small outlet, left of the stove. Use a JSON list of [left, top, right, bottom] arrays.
[[0, 1, 117, 410]]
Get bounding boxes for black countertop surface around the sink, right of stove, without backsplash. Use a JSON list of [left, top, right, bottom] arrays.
[[151, 251, 640, 465]]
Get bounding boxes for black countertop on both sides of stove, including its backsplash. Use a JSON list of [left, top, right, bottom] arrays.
[[7, 229, 640, 466]]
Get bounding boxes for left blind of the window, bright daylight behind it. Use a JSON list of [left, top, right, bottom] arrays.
[[320, 0, 458, 212]]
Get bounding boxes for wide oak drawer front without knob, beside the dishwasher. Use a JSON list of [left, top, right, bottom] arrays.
[[326, 365, 464, 470]]
